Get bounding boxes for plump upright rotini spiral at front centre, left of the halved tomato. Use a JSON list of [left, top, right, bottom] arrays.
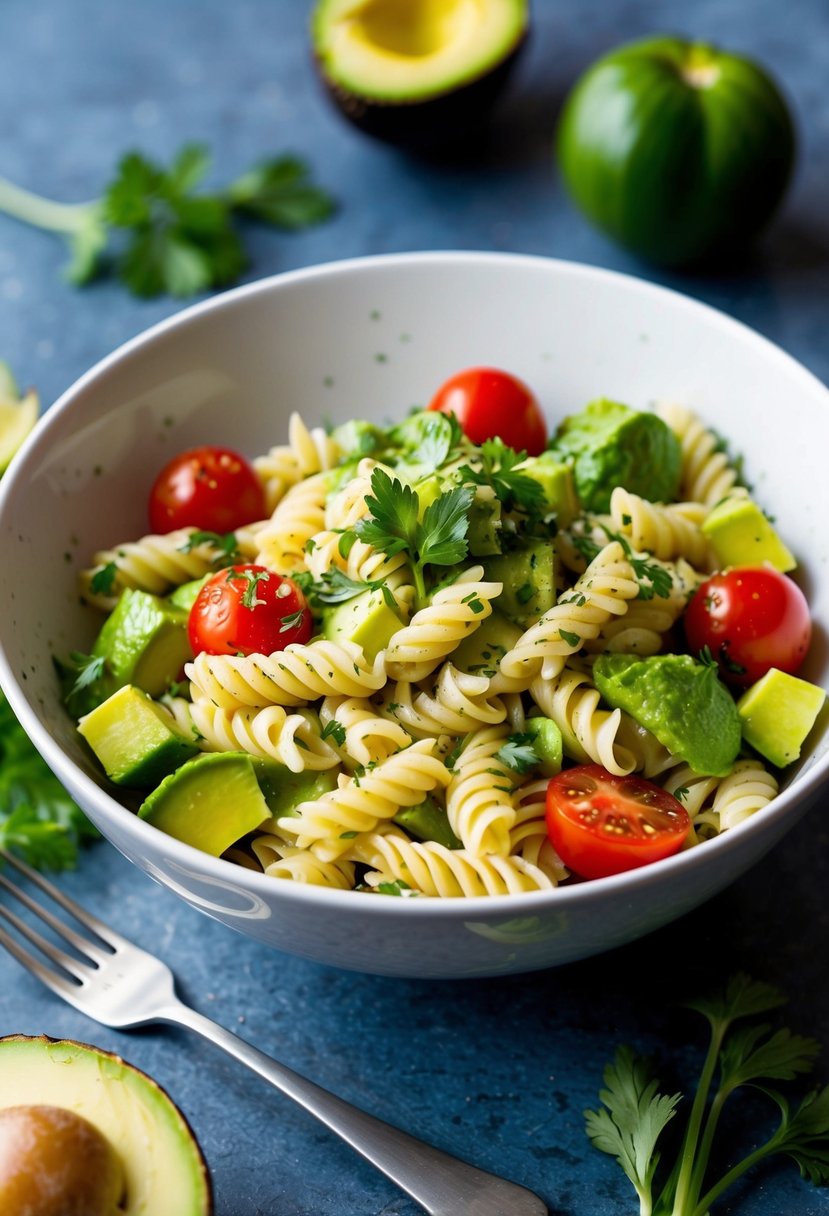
[[446, 725, 515, 857]]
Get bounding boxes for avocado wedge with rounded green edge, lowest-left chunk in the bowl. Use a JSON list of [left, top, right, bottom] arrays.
[[139, 751, 270, 857]]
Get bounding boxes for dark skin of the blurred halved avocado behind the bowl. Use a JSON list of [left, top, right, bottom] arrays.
[[315, 36, 529, 157]]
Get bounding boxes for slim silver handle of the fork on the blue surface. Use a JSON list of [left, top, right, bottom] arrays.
[[157, 1001, 547, 1216]]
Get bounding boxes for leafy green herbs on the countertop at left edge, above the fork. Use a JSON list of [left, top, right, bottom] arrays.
[[0, 693, 97, 869]]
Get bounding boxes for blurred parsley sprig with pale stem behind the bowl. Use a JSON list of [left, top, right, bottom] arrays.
[[0, 143, 334, 298]]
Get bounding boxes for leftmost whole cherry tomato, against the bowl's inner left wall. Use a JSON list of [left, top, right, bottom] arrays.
[[150, 445, 266, 533]]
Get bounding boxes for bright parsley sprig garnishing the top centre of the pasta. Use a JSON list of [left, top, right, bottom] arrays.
[[354, 467, 473, 603]]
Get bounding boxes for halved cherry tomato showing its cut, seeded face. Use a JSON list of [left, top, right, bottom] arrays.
[[547, 764, 690, 878]]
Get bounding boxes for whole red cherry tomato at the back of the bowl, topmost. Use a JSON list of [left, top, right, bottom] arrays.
[[429, 367, 547, 456]]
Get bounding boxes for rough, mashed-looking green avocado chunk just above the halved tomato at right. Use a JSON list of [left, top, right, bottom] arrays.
[[593, 654, 741, 777]]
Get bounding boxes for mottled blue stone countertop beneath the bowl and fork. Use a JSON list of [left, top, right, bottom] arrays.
[[0, 0, 829, 1216]]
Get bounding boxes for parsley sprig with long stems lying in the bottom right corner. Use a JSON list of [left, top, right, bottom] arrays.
[[585, 973, 829, 1216]]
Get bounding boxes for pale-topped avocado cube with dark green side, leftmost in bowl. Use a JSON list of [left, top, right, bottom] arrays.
[[78, 685, 198, 789]]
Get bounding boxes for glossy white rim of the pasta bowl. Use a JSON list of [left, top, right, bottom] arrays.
[[0, 249, 829, 921]]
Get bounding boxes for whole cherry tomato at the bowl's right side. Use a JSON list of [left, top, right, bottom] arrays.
[[684, 565, 812, 687]]
